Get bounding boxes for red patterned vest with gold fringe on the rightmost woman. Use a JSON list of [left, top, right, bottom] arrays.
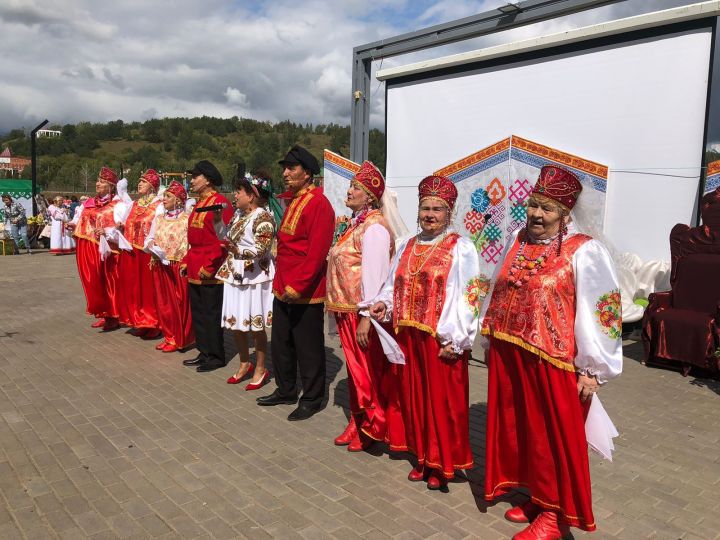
[[481, 233, 592, 371]]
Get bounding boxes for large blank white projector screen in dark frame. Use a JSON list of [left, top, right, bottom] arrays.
[[386, 28, 711, 261]]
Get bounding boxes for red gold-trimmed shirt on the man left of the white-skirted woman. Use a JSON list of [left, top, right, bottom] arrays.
[[183, 193, 234, 285]]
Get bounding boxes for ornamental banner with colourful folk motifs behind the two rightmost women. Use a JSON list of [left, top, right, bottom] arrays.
[[435, 135, 608, 279]]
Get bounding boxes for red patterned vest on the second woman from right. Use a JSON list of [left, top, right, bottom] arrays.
[[393, 233, 460, 336]]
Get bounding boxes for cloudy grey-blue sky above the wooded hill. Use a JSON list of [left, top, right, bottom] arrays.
[[0, 0, 691, 132]]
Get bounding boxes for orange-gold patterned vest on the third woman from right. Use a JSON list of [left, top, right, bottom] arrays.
[[325, 210, 395, 313]]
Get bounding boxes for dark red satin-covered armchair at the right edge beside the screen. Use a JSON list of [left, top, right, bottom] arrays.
[[642, 188, 720, 375]]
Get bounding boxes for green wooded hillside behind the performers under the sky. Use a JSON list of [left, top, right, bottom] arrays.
[[0, 116, 385, 191]]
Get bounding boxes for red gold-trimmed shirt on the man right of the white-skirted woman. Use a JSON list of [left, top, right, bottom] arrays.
[[273, 184, 335, 304]]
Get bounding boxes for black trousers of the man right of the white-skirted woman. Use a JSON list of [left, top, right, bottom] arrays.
[[271, 298, 325, 407]]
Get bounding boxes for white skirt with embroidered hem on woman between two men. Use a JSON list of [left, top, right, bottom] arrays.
[[221, 281, 273, 332]]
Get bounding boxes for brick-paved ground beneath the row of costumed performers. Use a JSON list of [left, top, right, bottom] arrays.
[[0, 253, 720, 540]]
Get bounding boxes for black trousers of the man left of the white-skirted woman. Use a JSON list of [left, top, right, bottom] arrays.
[[188, 283, 225, 366]]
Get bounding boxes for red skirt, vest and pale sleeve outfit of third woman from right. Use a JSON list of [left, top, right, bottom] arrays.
[[325, 210, 394, 441]]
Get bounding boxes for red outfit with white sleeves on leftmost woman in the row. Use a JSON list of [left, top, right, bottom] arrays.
[[72, 195, 125, 319]]
